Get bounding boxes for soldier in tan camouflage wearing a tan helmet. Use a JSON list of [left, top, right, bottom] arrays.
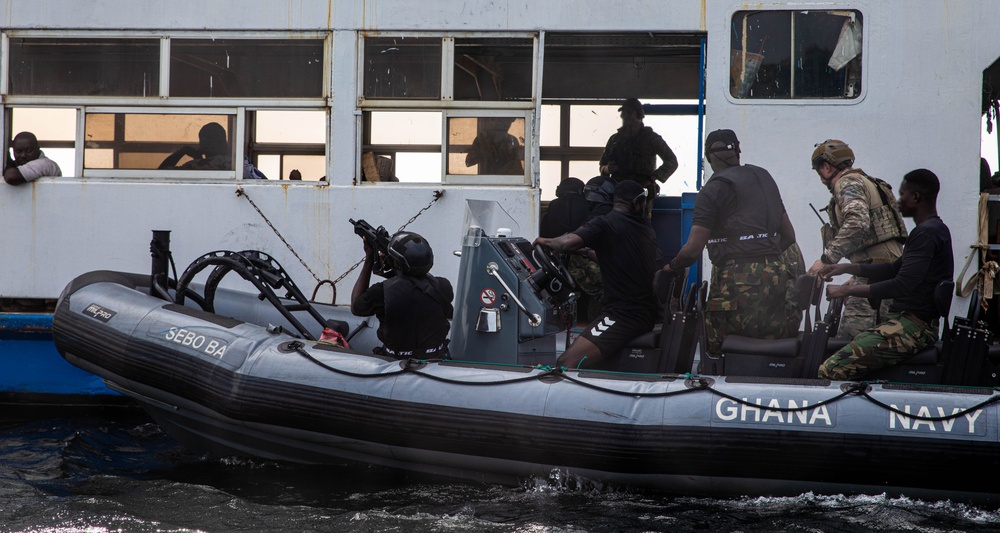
[[809, 139, 906, 338]]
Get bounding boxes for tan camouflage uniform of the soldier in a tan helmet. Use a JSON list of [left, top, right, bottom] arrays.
[[823, 168, 906, 339]]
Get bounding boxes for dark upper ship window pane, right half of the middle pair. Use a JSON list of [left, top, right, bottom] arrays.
[[454, 38, 535, 101]]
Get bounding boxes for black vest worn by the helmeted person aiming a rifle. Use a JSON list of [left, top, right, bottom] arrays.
[[379, 275, 451, 358]]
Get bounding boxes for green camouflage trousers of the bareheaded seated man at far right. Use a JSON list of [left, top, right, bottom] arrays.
[[818, 312, 938, 381]]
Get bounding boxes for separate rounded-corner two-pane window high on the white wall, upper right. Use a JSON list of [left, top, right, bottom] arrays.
[[722, 5, 869, 106]]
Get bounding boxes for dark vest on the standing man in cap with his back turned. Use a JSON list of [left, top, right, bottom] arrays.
[[708, 165, 784, 264]]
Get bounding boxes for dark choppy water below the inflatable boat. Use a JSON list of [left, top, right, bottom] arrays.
[[0, 417, 1000, 533]]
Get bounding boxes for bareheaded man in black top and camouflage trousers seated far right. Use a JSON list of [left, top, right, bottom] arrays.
[[819, 168, 955, 380]]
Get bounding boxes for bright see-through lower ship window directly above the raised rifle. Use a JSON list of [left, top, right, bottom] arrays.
[[360, 111, 442, 183]]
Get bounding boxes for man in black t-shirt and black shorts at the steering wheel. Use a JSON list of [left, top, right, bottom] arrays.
[[535, 181, 659, 368]]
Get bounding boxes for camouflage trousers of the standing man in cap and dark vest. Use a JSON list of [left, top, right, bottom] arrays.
[[705, 254, 802, 354]]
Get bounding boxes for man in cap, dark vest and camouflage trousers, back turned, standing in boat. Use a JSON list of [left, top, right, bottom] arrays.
[[663, 130, 802, 354]]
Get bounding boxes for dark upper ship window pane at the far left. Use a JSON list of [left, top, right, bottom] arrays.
[[9, 38, 160, 96]]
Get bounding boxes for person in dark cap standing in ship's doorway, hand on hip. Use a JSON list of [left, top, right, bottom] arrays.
[[599, 98, 677, 219]]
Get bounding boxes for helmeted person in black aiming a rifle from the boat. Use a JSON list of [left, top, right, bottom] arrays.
[[351, 231, 455, 359]]
